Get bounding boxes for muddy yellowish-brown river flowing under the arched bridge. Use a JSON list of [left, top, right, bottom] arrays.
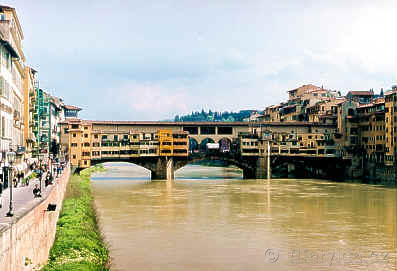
[[92, 163, 397, 271]]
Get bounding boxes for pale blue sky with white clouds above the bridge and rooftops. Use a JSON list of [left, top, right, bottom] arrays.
[[2, 0, 397, 120]]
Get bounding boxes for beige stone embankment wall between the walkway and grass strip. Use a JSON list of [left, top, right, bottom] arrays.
[[0, 166, 70, 271]]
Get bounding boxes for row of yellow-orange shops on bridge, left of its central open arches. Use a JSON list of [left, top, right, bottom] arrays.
[[60, 119, 189, 168]]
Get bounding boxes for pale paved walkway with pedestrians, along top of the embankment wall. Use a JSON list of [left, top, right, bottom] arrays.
[[0, 172, 65, 226]]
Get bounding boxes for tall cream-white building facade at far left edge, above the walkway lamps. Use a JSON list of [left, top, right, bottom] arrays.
[[0, 6, 25, 168]]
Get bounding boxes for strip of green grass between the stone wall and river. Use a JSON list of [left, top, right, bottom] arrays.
[[41, 166, 109, 271]]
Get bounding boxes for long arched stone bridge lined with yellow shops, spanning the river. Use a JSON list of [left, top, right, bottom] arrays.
[[61, 119, 337, 179]]
